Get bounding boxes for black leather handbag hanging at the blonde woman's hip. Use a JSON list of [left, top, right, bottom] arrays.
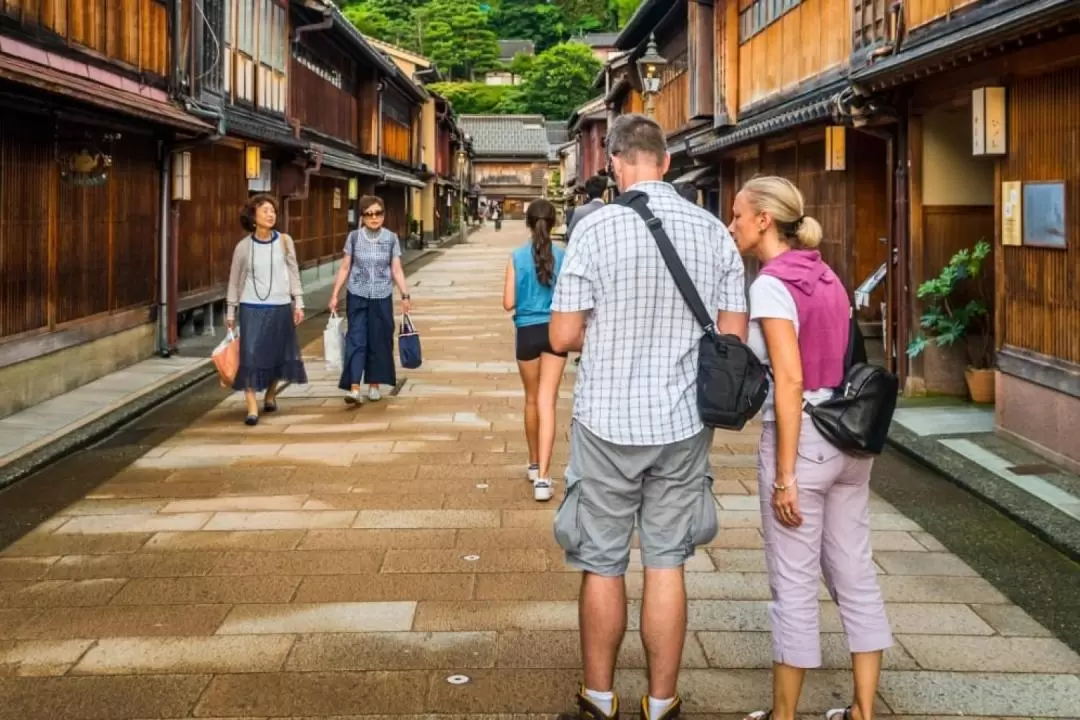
[[802, 311, 900, 456]]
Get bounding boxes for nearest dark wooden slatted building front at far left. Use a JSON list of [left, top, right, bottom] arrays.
[[0, 0, 213, 417]]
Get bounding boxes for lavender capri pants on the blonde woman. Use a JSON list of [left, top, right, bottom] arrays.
[[757, 416, 892, 668]]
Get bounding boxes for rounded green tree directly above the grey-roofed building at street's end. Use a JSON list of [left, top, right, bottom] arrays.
[[503, 42, 602, 120]]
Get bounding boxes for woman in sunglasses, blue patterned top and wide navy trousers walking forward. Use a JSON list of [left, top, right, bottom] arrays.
[[329, 195, 413, 405]]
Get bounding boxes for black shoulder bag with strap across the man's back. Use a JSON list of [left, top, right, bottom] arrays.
[[613, 190, 769, 430]]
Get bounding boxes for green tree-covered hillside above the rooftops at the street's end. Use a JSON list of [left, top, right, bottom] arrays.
[[342, 0, 642, 120]]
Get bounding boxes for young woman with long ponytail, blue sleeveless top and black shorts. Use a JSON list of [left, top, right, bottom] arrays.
[[502, 200, 566, 502]]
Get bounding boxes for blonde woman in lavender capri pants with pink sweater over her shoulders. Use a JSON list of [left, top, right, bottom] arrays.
[[731, 177, 892, 720]]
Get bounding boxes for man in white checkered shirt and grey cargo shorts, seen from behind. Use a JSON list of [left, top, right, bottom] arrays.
[[550, 114, 747, 720]]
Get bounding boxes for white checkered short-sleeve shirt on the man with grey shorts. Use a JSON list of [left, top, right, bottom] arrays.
[[552, 182, 746, 446]]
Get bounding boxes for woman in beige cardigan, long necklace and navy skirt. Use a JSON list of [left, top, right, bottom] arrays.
[[225, 195, 308, 425]]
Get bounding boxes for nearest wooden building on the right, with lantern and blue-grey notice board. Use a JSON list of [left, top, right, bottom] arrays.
[[851, 0, 1080, 470]]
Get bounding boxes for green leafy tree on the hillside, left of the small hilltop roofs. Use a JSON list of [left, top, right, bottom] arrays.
[[415, 0, 499, 80]]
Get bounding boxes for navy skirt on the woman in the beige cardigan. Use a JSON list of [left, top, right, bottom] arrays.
[[232, 303, 308, 391]]
